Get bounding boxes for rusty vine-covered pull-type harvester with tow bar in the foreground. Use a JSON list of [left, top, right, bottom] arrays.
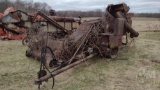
[[26, 3, 139, 86]]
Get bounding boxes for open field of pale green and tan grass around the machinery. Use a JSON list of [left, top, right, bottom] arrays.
[[0, 18, 160, 90]]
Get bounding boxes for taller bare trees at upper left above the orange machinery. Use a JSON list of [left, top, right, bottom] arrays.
[[0, 0, 51, 14]]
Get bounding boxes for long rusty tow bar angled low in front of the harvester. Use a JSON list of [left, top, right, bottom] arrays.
[[35, 53, 97, 84]]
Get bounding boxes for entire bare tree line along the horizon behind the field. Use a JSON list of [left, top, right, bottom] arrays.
[[0, 0, 160, 18]]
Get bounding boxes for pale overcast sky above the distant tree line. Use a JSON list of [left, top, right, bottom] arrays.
[[33, 0, 160, 13]]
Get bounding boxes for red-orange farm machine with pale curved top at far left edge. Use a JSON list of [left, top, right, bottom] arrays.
[[0, 7, 26, 40]]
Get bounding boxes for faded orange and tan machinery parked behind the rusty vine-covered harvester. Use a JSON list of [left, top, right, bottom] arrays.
[[0, 7, 81, 45]]
